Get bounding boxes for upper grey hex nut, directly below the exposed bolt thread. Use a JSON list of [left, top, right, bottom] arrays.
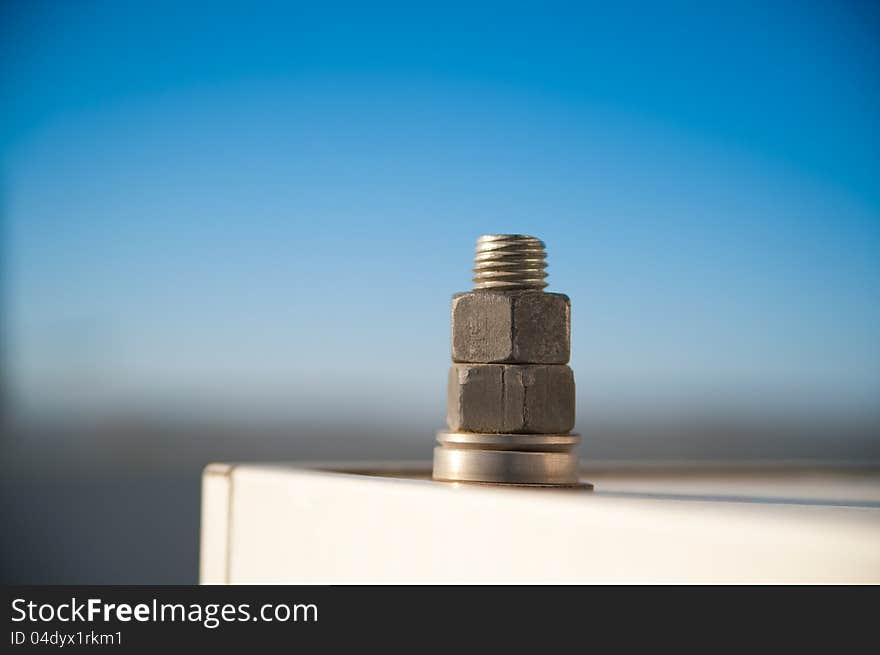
[[452, 291, 571, 364]]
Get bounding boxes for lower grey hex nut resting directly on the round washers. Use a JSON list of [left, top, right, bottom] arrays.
[[446, 364, 575, 434]]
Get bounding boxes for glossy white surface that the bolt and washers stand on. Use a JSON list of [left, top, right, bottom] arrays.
[[200, 464, 880, 584]]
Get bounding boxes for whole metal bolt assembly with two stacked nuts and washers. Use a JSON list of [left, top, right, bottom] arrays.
[[434, 235, 577, 485]]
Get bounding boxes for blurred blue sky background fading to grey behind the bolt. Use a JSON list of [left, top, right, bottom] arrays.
[[0, 0, 880, 583]]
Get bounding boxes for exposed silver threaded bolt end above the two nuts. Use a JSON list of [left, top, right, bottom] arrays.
[[474, 234, 547, 291]]
